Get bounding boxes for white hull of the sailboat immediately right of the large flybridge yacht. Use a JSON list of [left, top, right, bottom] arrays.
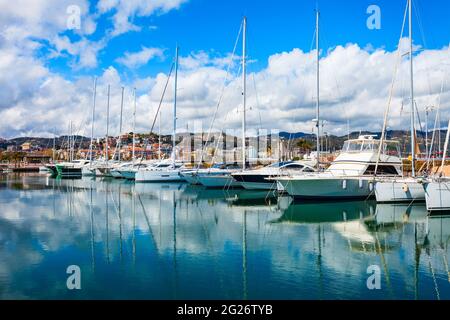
[[375, 179, 425, 202]]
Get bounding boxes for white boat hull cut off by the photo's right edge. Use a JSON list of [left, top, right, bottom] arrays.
[[423, 181, 450, 211]]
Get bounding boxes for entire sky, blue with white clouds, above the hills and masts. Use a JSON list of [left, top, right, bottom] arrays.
[[0, 0, 450, 138]]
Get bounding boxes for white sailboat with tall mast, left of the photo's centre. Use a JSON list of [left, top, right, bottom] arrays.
[[135, 46, 184, 182]]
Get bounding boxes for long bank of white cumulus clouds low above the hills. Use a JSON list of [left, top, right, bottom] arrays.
[[0, 44, 450, 137]]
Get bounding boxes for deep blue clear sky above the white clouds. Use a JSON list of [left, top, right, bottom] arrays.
[[49, 0, 450, 78]]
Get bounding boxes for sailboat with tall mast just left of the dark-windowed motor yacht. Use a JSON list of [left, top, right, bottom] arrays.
[[195, 17, 247, 188]]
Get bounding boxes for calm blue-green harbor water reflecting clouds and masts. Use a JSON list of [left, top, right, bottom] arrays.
[[0, 174, 450, 299]]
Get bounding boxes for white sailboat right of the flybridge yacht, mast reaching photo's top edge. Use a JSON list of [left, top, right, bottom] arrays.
[[375, 0, 425, 202]]
